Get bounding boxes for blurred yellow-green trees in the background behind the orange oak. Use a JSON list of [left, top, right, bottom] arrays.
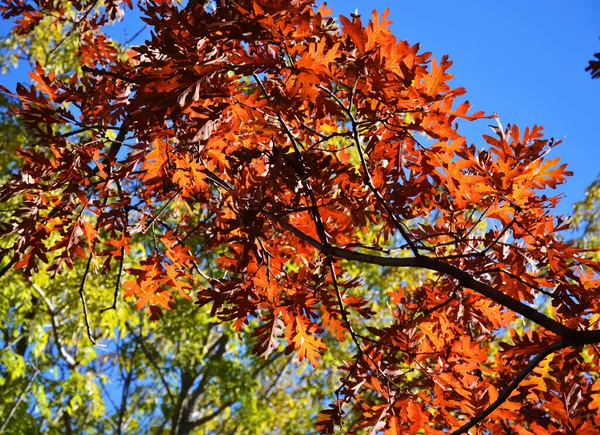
[[0, 5, 356, 434]]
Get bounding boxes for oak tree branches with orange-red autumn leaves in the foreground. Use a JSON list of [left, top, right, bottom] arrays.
[[0, 0, 600, 434]]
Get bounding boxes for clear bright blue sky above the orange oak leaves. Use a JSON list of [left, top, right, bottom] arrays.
[[0, 0, 600, 217]]
